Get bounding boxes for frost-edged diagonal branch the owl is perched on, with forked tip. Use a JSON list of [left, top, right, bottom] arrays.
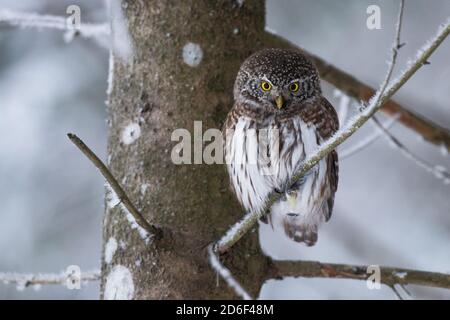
[[216, 10, 450, 253]]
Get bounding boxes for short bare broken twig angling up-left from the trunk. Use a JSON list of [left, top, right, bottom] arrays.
[[67, 133, 161, 236]]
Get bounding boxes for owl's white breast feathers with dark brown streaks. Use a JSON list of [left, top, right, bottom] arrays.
[[225, 117, 327, 244]]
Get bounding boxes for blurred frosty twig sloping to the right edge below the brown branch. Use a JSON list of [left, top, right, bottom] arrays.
[[372, 116, 450, 185]]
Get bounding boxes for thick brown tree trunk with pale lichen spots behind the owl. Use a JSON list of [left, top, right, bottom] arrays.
[[101, 0, 268, 299]]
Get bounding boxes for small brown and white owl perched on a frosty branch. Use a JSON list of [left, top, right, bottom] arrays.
[[222, 49, 339, 246]]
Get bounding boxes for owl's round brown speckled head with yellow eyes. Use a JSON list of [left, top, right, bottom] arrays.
[[234, 49, 321, 111]]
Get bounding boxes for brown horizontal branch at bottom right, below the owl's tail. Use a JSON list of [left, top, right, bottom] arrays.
[[266, 261, 450, 289]]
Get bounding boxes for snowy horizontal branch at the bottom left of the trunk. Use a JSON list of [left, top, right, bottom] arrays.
[[0, 270, 100, 290]]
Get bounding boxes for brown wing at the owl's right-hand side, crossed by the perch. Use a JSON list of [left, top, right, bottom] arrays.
[[316, 97, 339, 221]]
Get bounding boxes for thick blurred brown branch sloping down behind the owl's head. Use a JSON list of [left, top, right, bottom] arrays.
[[264, 31, 450, 151]]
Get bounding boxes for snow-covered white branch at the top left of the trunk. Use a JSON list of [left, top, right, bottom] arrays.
[[0, 8, 110, 41]]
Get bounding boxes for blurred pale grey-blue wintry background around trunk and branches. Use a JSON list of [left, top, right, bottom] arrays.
[[0, 0, 450, 299]]
